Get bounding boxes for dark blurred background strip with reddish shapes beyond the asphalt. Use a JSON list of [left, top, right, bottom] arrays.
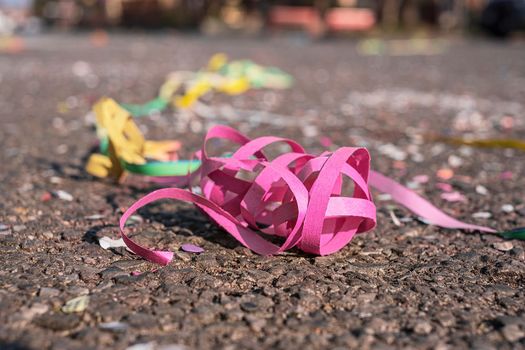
[[0, 0, 525, 38]]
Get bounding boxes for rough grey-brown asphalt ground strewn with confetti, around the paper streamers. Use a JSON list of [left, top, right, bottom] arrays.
[[0, 34, 525, 350]]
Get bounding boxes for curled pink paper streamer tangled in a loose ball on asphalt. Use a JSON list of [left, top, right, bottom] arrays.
[[120, 126, 495, 265]]
